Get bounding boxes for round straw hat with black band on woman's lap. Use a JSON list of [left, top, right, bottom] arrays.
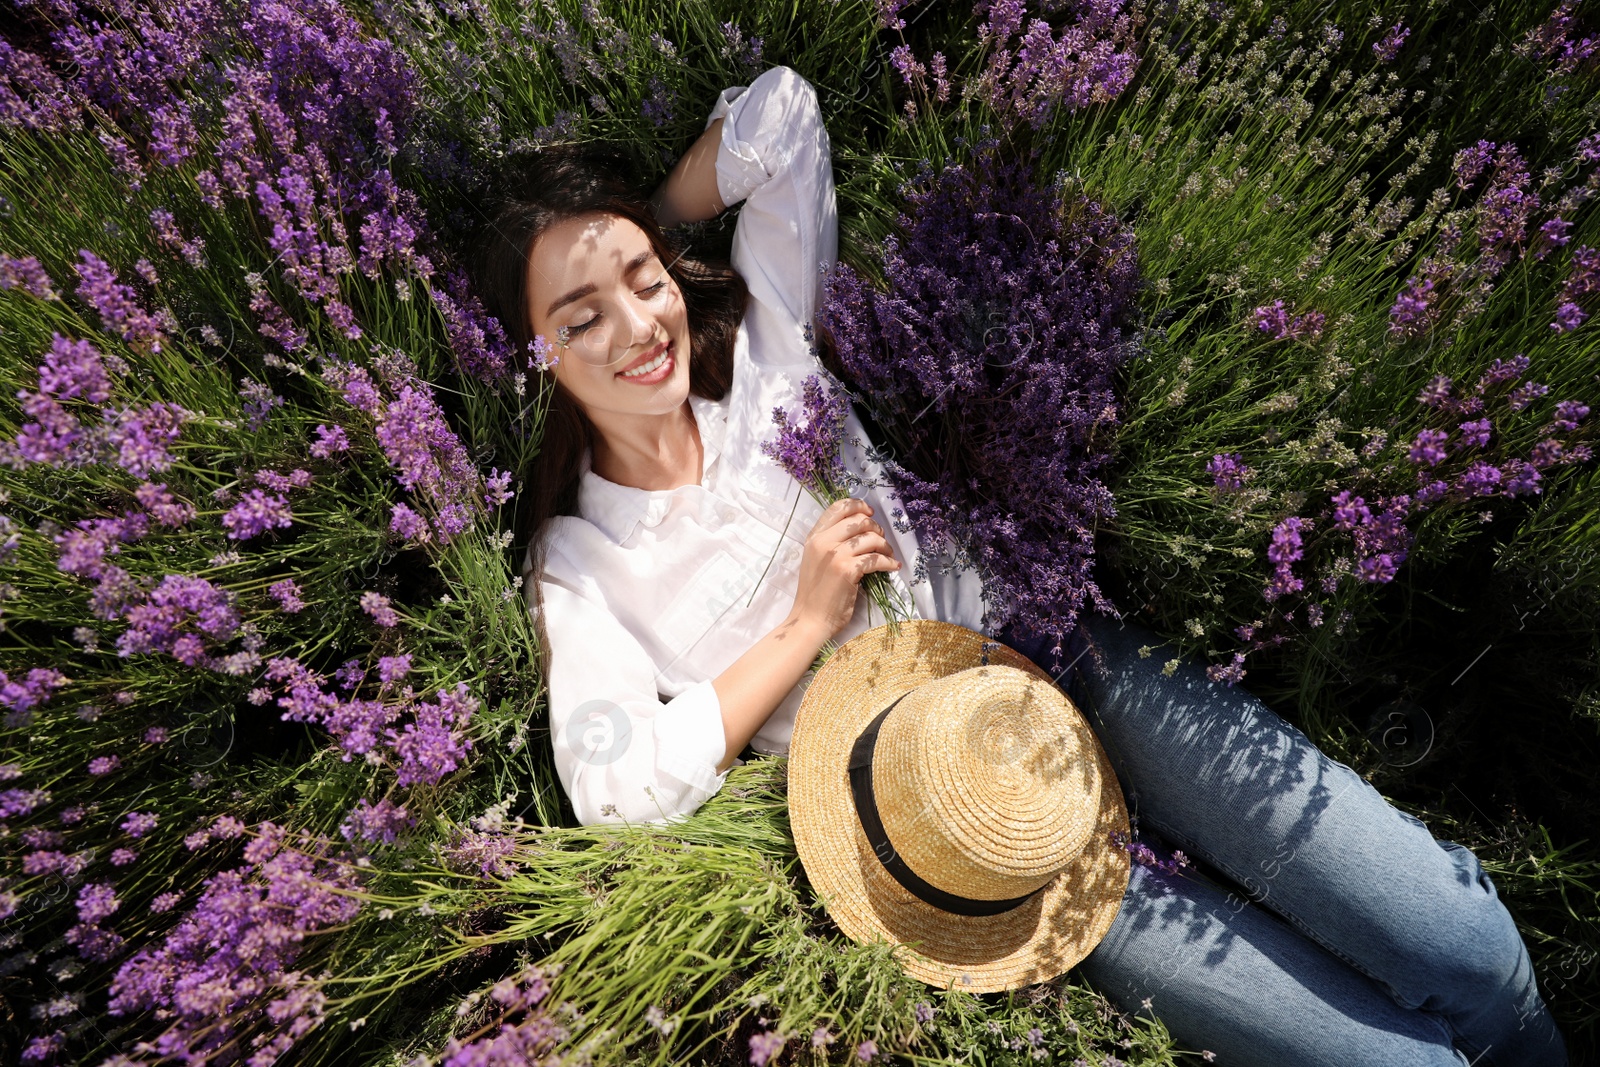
[[789, 619, 1130, 993]]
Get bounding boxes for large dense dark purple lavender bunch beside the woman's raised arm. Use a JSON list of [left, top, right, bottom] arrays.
[[819, 142, 1138, 668]]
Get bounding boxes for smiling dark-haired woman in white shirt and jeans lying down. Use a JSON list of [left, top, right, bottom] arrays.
[[485, 67, 1566, 1067]]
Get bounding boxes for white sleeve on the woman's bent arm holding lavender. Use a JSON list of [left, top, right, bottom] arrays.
[[539, 581, 726, 825]]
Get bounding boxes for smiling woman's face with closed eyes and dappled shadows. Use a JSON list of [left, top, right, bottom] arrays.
[[528, 214, 691, 418]]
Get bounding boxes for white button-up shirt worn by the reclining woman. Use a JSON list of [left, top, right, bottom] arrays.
[[523, 67, 984, 824]]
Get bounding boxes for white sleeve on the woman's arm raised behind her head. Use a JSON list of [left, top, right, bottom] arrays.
[[706, 67, 838, 337]]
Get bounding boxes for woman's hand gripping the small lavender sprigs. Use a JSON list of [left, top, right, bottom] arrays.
[[792, 496, 901, 640]]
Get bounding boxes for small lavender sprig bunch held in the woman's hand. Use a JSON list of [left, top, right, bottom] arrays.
[[757, 374, 910, 633]]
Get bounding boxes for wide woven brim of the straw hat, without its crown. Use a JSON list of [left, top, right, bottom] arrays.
[[789, 619, 1131, 993]]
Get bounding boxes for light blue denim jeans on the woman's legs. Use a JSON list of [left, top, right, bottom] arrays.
[[995, 611, 1566, 1067]]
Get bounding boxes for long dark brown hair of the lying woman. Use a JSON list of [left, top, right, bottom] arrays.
[[478, 144, 749, 677]]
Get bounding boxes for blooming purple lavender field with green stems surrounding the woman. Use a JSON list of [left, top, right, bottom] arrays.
[[0, 0, 1600, 1067]]
